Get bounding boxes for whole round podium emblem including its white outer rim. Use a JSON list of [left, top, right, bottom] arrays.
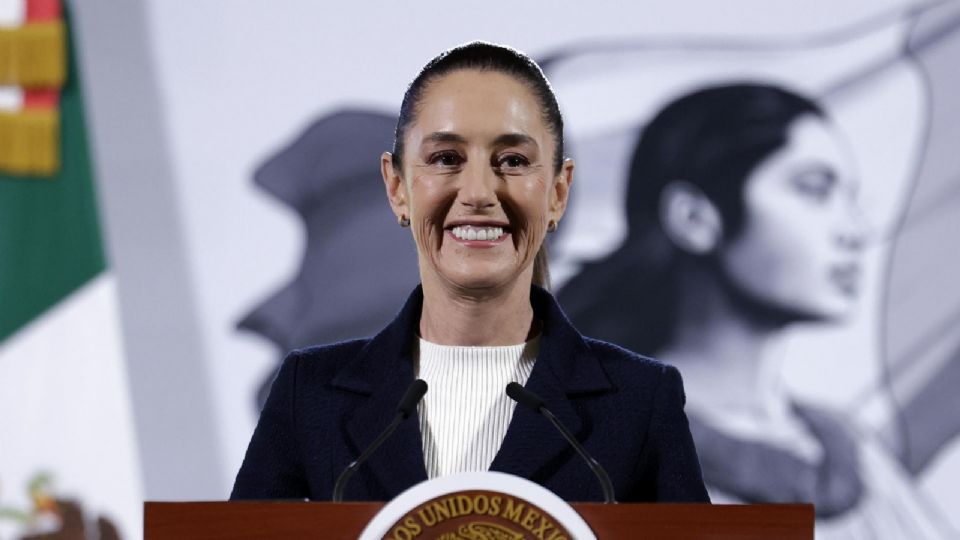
[[360, 472, 595, 540]]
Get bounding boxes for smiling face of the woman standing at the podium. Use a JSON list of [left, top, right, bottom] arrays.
[[381, 70, 573, 296]]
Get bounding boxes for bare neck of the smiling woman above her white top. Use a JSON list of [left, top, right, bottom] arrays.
[[420, 276, 536, 346]]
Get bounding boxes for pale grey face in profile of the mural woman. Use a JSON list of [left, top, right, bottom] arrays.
[[720, 115, 865, 320]]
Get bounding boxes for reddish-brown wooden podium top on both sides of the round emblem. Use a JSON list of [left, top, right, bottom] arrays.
[[143, 502, 814, 540]]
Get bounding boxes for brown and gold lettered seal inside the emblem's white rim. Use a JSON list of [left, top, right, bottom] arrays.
[[383, 490, 573, 540]]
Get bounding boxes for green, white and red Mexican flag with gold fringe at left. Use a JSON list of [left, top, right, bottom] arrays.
[[0, 0, 142, 538]]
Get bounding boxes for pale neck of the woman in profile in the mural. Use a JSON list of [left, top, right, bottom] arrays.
[[657, 266, 790, 422]]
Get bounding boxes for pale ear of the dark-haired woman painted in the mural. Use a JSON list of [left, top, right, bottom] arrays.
[[660, 180, 723, 255]]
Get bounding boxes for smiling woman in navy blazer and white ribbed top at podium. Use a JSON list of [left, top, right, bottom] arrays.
[[231, 42, 708, 501]]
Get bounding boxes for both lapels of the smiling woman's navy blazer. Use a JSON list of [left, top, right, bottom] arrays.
[[332, 286, 613, 495]]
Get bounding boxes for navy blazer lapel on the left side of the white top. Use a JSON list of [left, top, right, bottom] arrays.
[[333, 287, 427, 498]]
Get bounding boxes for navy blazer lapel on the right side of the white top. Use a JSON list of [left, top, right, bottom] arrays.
[[490, 287, 612, 483]]
